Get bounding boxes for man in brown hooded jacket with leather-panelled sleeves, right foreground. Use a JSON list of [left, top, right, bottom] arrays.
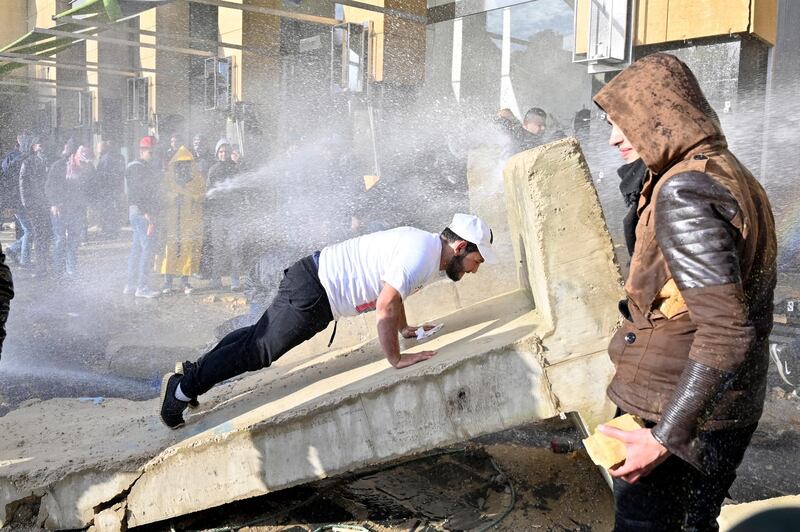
[[594, 53, 777, 530]]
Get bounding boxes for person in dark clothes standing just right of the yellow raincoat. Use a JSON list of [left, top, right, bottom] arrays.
[[206, 139, 242, 292]]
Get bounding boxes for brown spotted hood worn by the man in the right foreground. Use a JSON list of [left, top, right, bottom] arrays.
[[594, 53, 726, 174]]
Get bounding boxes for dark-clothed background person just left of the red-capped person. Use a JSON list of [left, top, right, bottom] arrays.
[[96, 140, 125, 239]]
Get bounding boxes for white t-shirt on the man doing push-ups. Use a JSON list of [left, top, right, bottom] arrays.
[[319, 227, 442, 319]]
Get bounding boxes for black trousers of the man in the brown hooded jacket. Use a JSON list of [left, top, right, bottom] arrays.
[[614, 425, 756, 532]]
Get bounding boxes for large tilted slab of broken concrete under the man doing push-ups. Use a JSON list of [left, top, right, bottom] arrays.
[[0, 139, 621, 530]]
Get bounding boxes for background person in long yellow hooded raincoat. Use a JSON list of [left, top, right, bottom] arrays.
[[156, 146, 206, 294]]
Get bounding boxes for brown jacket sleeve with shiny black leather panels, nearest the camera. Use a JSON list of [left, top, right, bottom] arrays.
[[653, 172, 755, 472]]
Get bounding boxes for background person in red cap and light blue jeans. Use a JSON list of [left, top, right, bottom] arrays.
[[122, 135, 161, 298]]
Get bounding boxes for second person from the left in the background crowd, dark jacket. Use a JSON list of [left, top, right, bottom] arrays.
[[19, 137, 53, 275]]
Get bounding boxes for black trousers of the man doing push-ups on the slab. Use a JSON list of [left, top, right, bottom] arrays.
[[181, 253, 333, 397]]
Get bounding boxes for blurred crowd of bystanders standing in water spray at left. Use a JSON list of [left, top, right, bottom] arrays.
[[0, 132, 250, 298]]
